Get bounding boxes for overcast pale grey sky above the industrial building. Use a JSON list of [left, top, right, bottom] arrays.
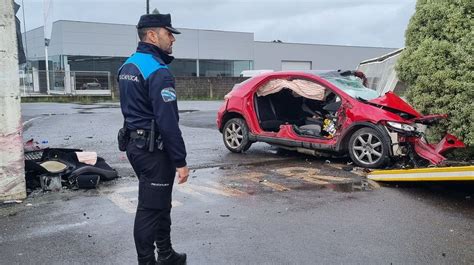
[[15, 0, 416, 48]]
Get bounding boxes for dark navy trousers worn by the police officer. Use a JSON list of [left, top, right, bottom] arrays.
[[127, 139, 176, 262]]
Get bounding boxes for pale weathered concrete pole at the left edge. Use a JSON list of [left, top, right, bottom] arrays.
[[0, 0, 26, 201]]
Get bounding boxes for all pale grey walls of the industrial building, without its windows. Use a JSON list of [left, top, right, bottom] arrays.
[[27, 20, 395, 75]]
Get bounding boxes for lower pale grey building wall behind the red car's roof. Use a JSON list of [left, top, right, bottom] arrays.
[[254, 41, 396, 71]]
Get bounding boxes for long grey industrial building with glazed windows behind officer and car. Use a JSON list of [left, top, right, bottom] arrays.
[[22, 20, 396, 94]]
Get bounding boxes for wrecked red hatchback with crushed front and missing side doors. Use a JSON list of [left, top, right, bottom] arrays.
[[217, 71, 464, 168]]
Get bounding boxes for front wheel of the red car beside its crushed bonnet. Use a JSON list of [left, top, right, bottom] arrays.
[[348, 127, 389, 168]]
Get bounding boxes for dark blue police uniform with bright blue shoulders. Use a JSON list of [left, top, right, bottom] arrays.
[[118, 42, 186, 262]]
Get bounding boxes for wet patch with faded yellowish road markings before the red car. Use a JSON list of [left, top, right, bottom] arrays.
[[185, 160, 372, 197]]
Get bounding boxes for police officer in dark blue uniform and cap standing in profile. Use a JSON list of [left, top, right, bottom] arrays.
[[118, 14, 189, 264]]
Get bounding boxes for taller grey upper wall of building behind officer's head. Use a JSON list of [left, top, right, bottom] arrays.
[[27, 20, 253, 60]]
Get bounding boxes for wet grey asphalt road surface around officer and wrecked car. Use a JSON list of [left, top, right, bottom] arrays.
[[0, 102, 474, 264]]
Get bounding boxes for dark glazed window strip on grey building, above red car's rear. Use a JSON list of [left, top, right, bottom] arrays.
[[199, 60, 253, 77]]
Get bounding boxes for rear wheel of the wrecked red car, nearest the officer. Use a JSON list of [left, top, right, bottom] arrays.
[[222, 118, 252, 153]]
